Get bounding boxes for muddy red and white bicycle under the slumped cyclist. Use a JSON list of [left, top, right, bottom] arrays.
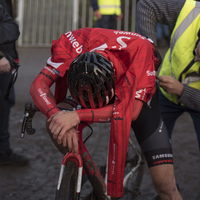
[[21, 102, 145, 200]]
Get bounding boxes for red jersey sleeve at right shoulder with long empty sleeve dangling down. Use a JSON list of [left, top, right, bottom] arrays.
[[107, 40, 156, 197]]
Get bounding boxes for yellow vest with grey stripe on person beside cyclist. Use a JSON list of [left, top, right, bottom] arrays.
[[159, 0, 200, 104]]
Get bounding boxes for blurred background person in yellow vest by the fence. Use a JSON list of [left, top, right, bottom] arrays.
[[91, 0, 123, 29]]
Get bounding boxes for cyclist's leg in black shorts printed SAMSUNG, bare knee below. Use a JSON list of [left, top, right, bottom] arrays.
[[132, 88, 182, 200]]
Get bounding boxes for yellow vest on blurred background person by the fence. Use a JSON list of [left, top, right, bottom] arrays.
[[98, 0, 121, 16]]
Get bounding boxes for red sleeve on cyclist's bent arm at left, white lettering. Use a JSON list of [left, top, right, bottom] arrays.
[[30, 66, 60, 118]]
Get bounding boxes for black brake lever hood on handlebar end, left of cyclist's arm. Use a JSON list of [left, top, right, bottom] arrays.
[[21, 102, 39, 138]]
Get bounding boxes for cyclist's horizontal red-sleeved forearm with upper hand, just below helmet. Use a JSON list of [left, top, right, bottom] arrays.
[[47, 99, 143, 138]]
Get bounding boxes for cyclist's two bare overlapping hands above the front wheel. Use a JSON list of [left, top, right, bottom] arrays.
[[47, 111, 80, 153]]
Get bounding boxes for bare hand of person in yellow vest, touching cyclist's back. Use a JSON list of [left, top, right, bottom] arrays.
[[158, 76, 183, 95]]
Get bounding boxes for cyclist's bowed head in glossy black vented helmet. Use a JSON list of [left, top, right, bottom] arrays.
[[68, 52, 115, 108]]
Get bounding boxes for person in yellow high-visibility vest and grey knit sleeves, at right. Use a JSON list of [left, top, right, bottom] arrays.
[[136, 0, 200, 148]]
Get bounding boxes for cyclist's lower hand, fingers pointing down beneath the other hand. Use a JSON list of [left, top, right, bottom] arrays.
[[61, 128, 78, 154]]
